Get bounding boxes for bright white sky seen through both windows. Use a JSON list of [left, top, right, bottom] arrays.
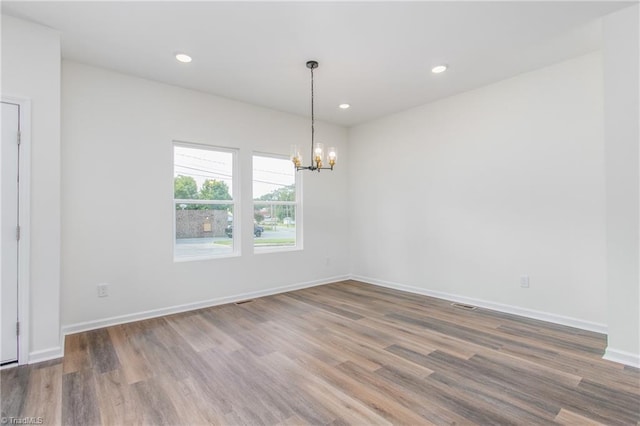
[[174, 145, 295, 199]]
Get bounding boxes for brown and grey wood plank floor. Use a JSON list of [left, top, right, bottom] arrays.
[[1, 281, 640, 425]]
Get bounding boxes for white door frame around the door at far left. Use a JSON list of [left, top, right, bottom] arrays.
[[0, 95, 31, 365]]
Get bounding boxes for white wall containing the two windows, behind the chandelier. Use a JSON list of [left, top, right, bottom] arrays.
[[62, 61, 349, 330]]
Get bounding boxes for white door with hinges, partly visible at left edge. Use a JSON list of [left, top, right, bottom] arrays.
[[0, 102, 20, 363]]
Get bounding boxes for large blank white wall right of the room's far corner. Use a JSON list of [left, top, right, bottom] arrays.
[[349, 53, 607, 330]]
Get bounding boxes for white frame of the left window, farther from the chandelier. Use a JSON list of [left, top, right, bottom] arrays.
[[171, 140, 242, 263]]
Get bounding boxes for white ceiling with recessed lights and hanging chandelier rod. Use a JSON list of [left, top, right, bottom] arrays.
[[2, 1, 630, 126]]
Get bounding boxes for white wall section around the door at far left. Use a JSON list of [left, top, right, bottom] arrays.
[[2, 15, 60, 361]]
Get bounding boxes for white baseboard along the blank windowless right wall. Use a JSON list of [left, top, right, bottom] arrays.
[[351, 275, 607, 334]]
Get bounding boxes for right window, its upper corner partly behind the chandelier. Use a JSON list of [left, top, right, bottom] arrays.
[[253, 154, 302, 251]]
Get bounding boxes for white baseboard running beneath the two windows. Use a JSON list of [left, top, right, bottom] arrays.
[[62, 275, 349, 336]]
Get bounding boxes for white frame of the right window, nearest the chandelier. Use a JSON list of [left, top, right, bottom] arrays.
[[251, 151, 304, 254]]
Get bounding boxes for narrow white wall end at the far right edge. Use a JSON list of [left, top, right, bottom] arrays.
[[603, 5, 640, 367]]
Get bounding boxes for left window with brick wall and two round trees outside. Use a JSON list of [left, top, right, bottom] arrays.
[[173, 143, 238, 260]]
